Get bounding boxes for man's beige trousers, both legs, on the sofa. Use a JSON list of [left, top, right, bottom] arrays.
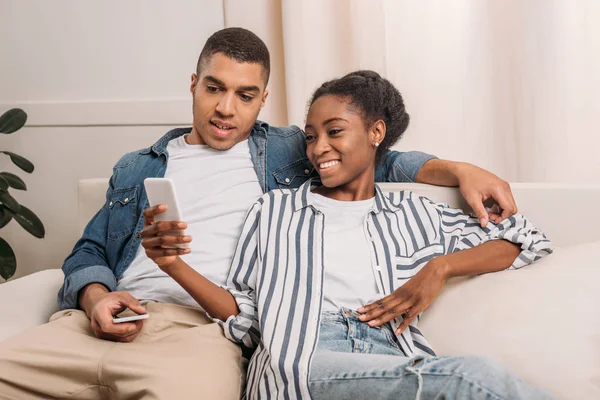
[[0, 302, 246, 400]]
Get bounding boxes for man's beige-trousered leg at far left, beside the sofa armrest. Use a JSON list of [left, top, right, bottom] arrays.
[[0, 310, 115, 400]]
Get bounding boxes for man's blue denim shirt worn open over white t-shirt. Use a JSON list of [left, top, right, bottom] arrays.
[[58, 121, 434, 309]]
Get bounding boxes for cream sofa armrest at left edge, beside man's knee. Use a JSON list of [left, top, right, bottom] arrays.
[[0, 269, 64, 341]]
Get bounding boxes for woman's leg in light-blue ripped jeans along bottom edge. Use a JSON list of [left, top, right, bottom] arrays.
[[309, 350, 551, 400]]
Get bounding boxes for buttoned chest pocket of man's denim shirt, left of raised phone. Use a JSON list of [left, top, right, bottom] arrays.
[[108, 187, 137, 240]]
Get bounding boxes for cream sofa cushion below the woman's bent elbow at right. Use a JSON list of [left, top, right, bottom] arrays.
[[420, 242, 600, 399]]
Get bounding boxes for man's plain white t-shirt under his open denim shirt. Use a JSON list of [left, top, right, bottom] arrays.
[[117, 136, 262, 307]]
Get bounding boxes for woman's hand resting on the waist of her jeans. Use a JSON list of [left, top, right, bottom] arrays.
[[357, 256, 447, 335]]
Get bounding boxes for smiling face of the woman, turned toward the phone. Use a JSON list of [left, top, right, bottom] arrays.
[[304, 95, 385, 188]]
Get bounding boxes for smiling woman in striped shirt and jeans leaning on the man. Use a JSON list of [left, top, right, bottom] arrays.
[[154, 71, 552, 399]]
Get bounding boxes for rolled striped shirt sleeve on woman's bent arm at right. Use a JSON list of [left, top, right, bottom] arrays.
[[432, 199, 552, 269]]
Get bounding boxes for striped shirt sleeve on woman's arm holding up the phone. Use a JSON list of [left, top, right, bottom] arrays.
[[213, 200, 262, 349]]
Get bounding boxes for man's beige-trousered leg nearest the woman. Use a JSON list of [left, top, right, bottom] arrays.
[[102, 303, 246, 400]]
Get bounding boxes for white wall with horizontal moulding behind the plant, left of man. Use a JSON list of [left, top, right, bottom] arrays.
[[0, 0, 229, 277]]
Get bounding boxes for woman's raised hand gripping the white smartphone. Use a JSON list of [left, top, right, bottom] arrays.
[[141, 204, 192, 273]]
